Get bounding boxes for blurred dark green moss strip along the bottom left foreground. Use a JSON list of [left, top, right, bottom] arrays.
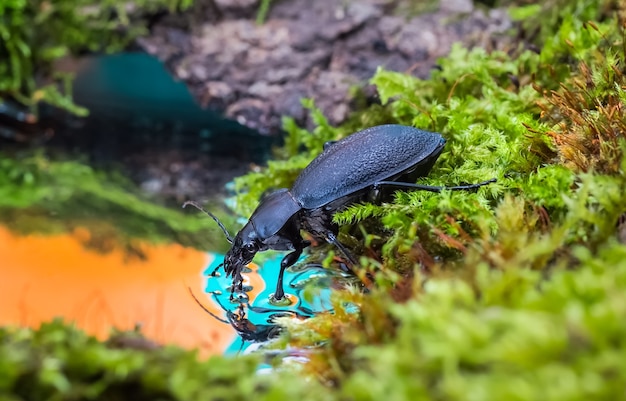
[[0, 320, 322, 400]]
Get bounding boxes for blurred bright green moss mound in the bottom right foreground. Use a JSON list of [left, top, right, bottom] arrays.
[[334, 242, 626, 400]]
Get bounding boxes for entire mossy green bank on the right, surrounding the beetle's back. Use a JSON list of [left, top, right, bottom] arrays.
[[228, 0, 626, 400]]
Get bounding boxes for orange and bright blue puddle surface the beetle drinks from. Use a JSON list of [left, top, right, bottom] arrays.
[[0, 226, 342, 356]]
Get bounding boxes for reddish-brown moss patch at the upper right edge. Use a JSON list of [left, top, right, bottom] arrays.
[[538, 23, 626, 175]]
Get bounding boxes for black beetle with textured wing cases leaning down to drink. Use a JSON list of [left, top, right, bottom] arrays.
[[183, 125, 495, 299]]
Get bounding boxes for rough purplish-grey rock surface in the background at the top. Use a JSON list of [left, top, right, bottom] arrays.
[[139, 0, 511, 134]]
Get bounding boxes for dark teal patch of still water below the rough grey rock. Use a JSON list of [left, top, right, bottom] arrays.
[[68, 52, 276, 163]]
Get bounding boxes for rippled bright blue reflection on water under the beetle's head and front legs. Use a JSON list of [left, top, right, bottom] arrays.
[[203, 254, 332, 355]]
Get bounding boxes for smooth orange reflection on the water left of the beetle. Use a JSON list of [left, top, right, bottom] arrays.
[[0, 227, 235, 355]]
